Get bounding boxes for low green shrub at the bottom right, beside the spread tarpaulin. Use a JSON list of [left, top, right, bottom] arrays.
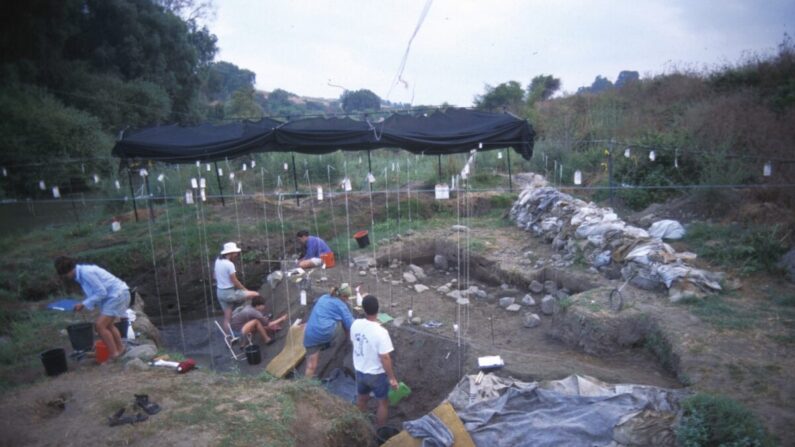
[[676, 393, 774, 447]]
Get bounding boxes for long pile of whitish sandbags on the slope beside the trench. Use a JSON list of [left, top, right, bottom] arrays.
[[510, 174, 724, 301]]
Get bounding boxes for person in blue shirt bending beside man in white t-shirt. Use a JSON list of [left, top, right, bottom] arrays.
[[304, 283, 353, 379]]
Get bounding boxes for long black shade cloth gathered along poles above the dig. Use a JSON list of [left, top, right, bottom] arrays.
[[113, 108, 535, 163]]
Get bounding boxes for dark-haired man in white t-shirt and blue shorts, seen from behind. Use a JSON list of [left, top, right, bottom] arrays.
[[351, 295, 398, 427]]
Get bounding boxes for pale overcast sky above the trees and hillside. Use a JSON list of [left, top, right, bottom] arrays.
[[208, 0, 795, 107]]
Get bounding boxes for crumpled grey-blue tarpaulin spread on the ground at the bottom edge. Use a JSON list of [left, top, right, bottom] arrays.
[[448, 374, 683, 446]]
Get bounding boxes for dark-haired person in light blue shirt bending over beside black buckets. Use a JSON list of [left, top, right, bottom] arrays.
[[55, 256, 130, 360]]
